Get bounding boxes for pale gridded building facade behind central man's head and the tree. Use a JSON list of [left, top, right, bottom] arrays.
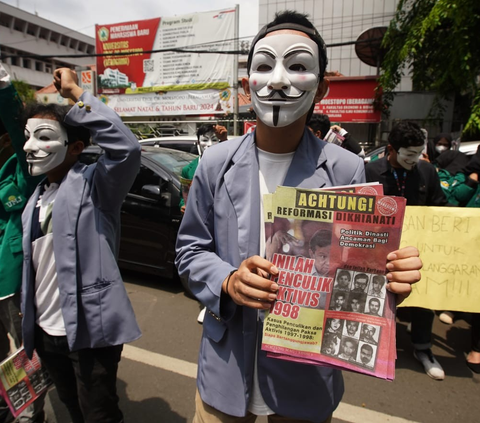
[[259, 0, 453, 146]]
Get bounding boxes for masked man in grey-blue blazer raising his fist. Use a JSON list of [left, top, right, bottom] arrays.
[[21, 68, 141, 423]]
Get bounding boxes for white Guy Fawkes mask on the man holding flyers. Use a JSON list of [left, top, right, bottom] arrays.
[[249, 34, 320, 127]]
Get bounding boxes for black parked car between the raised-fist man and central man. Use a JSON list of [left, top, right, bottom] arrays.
[[80, 145, 196, 294]]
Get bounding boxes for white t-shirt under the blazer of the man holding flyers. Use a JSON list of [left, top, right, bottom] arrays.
[[248, 148, 295, 416]]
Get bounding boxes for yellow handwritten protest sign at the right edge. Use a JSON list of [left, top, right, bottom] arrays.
[[401, 206, 480, 313]]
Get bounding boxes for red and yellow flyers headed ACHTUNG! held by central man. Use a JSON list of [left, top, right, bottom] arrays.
[[262, 184, 406, 380]]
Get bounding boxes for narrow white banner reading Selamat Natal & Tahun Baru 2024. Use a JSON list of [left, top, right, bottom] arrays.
[[100, 89, 233, 116]]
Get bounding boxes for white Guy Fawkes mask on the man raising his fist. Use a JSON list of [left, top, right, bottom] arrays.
[[23, 119, 68, 176]]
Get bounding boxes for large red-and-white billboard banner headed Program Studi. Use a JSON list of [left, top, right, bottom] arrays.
[[95, 9, 235, 94]]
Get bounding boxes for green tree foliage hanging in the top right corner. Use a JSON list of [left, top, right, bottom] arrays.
[[379, 0, 480, 137]]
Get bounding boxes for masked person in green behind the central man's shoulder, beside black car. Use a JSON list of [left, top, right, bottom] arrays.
[[179, 124, 228, 213]]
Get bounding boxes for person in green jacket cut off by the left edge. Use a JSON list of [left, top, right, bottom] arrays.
[[0, 63, 43, 423]]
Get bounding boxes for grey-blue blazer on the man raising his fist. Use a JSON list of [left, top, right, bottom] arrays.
[[22, 93, 141, 356]]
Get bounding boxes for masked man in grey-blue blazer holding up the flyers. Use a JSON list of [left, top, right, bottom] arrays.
[[175, 11, 421, 423]]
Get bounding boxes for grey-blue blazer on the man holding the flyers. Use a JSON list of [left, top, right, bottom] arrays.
[[176, 129, 365, 422]]
